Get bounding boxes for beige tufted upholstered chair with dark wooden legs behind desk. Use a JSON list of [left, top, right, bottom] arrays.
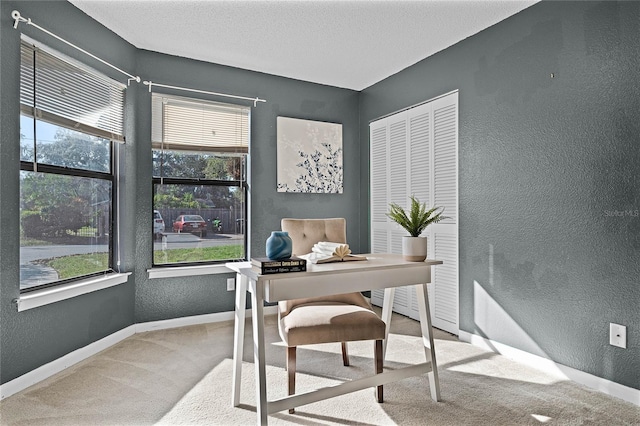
[[278, 218, 386, 413]]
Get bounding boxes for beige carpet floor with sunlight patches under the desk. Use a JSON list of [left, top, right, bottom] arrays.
[[0, 314, 640, 426]]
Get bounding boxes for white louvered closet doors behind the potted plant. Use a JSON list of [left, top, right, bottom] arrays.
[[370, 92, 458, 334]]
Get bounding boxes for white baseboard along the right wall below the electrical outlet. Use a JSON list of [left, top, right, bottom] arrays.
[[458, 330, 640, 406]]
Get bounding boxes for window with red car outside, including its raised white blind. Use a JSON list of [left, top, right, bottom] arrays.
[[150, 93, 250, 266]]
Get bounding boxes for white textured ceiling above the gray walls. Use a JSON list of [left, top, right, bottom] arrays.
[[70, 0, 537, 90]]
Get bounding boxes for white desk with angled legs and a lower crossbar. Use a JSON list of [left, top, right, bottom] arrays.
[[226, 254, 442, 424]]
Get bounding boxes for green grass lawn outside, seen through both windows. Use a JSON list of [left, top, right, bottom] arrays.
[[42, 244, 244, 280]]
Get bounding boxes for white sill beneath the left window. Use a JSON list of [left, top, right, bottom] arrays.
[[16, 272, 131, 312]]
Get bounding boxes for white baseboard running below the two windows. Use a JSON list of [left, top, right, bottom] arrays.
[[0, 306, 278, 400]]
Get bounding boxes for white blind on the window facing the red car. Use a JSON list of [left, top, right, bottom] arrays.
[[151, 93, 249, 154]]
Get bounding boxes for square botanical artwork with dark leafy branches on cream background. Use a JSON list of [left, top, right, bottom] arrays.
[[277, 117, 343, 194]]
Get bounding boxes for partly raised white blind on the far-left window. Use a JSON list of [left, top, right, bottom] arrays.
[[20, 40, 125, 142]]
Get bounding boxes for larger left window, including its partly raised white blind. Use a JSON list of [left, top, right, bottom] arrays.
[[16, 39, 124, 293]]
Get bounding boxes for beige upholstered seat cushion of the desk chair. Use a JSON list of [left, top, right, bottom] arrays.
[[278, 302, 385, 346]]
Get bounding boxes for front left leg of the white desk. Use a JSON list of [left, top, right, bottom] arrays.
[[249, 280, 267, 425]]
